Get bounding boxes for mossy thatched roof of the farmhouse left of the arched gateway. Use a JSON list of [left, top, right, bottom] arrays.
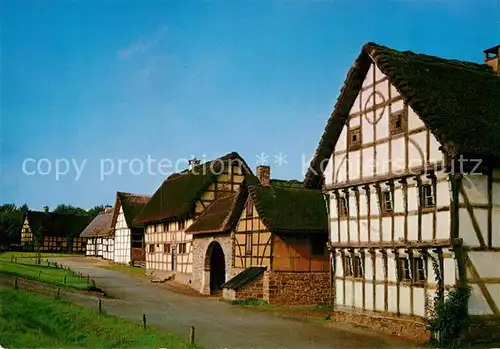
[[135, 152, 253, 223]]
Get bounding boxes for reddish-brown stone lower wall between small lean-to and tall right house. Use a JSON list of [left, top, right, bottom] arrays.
[[263, 271, 330, 305]]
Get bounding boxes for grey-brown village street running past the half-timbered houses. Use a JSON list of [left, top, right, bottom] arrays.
[[52, 257, 418, 349]]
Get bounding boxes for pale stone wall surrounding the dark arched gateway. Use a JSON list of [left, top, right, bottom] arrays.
[[191, 234, 234, 294]]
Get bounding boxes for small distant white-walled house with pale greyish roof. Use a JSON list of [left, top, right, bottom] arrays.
[[80, 208, 114, 260]]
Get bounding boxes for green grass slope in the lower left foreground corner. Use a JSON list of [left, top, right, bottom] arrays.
[[0, 288, 199, 349]]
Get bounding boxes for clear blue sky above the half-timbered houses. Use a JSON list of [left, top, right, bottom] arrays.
[[0, 0, 500, 209]]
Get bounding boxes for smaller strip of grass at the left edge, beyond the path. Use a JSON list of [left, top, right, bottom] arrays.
[[0, 252, 90, 290]]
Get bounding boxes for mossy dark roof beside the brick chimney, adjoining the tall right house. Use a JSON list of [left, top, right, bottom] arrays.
[[248, 181, 328, 233]]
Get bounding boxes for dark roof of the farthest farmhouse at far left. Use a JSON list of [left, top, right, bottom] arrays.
[[23, 211, 91, 237]]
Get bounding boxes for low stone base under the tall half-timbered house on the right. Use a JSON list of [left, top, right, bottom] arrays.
[[332, 310, 431, 343]]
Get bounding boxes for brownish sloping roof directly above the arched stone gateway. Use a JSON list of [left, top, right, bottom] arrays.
[[186, 186, 248, 235]]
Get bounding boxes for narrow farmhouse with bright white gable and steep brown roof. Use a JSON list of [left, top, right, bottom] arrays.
[[111, 192, 151, 265]]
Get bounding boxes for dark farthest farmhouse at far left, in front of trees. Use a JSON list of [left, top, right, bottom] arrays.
[[21, 206, 90, 253]]
